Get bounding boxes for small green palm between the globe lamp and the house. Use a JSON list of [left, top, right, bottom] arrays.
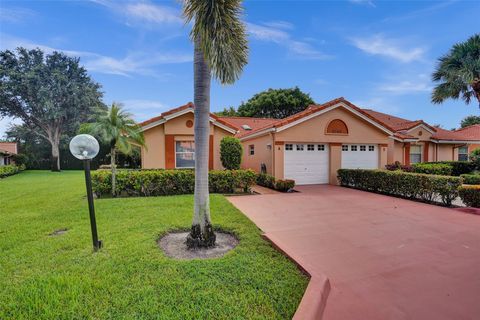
[[83, 102, 145, 197]]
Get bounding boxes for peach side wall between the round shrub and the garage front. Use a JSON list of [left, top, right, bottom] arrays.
[[242, 135, 273, 174]]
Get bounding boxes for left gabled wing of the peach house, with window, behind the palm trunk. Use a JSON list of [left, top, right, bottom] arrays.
[[140, 103, 238, 169]]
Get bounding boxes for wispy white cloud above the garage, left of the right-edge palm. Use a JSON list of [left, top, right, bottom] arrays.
[[352, 34, 425, 63]]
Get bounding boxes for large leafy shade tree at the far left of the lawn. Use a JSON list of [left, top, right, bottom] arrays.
[[0, 48, 102, 171]]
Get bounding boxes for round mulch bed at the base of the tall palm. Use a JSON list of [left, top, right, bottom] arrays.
[[158, 231, 238, 260]]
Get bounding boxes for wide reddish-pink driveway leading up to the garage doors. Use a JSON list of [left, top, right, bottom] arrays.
[[229, 185, 480, 320]]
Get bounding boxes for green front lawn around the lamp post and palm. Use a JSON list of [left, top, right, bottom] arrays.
[[0, 171, 308, 320]]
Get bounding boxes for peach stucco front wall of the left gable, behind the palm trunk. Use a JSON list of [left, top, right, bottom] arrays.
[[142, 113, 232, 170]]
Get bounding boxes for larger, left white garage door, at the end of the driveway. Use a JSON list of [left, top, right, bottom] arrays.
[[284, 143, 328, 185]]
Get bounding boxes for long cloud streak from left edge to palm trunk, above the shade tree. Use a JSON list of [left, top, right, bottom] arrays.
[[0, 34, 192, 77]]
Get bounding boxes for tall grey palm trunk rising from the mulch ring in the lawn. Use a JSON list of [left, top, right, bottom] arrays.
[[187, 40, 216, 248]]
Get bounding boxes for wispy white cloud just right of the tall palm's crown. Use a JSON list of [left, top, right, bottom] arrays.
[[246, 21, 331, 59]]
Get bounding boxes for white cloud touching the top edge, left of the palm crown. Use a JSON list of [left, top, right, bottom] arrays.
[[92, 0, 183, 25]]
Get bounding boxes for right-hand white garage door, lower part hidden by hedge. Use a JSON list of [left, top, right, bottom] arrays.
[[342, 144, 378, 169]]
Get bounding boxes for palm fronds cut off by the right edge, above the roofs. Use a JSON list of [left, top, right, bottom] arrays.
[[432, 34, 480, 106]]
